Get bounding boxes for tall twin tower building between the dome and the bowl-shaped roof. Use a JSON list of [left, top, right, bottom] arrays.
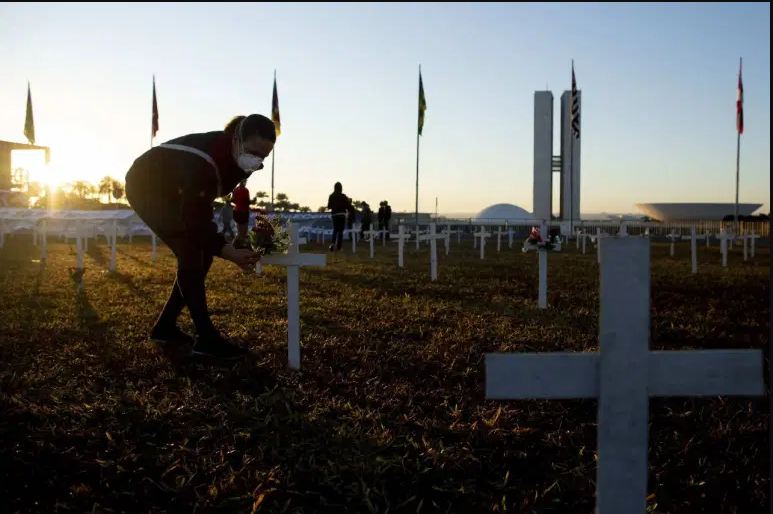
[[533, 91, 582, 225]]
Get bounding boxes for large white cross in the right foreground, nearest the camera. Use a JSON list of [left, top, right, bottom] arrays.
[[486, 238, 764, 514]]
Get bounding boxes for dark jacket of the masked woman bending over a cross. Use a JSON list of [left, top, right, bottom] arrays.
[[126, 130, 247, 255]]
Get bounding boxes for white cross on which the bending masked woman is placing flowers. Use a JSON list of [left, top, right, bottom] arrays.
[[261, 223, 327, 369]]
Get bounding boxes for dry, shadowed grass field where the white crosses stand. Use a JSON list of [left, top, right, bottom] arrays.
[[0, 236, 770, 514]]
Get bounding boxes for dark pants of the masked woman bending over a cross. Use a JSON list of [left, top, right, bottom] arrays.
[[126, 163, 216, 336]]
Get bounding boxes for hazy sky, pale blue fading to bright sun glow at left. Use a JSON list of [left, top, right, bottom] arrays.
[[0, 3, 770, 213]]
